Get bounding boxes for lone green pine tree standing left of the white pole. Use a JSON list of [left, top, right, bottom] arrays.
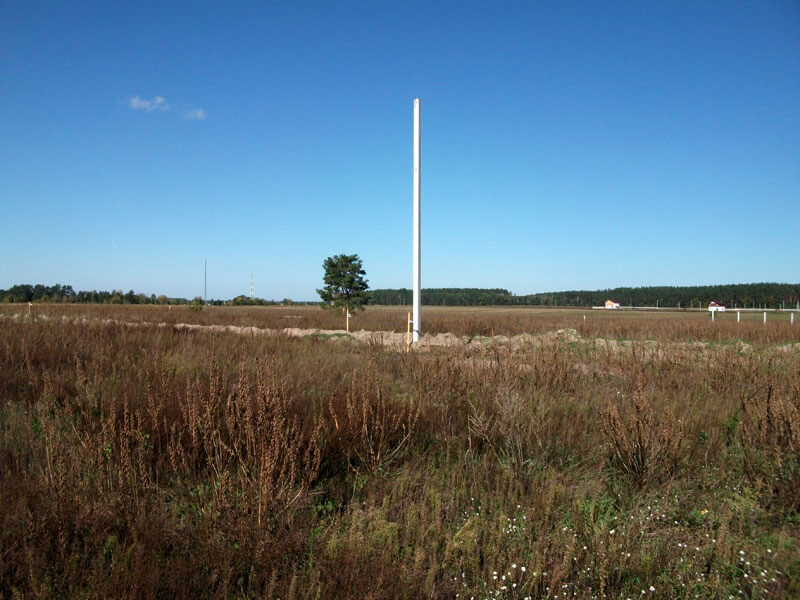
[[317, 254, 370, 331]]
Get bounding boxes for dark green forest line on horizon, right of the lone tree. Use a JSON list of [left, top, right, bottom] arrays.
[[371, 283, 800, 308]]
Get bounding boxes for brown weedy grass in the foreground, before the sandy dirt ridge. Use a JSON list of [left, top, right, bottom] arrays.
[[0, 309, 800, 598]]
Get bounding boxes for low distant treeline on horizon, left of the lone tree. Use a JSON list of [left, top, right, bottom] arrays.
[[0, 284, 304, 306]]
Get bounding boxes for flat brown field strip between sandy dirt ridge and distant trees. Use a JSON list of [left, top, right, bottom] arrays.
[[0, 304, 800, 344]]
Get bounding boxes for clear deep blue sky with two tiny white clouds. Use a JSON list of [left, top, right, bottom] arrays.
[[0, 0, 800, 299]]
